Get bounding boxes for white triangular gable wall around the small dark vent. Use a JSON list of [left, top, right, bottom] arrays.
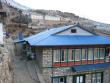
[[57, 27, 93, 35]]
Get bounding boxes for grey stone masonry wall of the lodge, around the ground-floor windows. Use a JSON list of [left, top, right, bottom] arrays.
[[42, 48, 110, 83]]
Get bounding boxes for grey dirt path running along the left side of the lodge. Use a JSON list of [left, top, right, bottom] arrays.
[[7, 38, 40, 83]]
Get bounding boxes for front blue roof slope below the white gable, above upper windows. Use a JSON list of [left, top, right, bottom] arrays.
[[29, 35, 110, 46]]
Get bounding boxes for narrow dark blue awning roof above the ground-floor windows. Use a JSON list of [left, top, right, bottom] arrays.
[[72, 63, 110, 72]]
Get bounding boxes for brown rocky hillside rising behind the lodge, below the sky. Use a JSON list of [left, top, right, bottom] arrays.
[[3, 0, 110, 35]]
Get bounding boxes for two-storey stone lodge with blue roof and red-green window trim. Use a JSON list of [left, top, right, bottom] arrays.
[[17, 25, 110, 83]]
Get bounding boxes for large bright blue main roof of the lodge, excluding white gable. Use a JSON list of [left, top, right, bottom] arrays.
[[16, 25, 110, 46]]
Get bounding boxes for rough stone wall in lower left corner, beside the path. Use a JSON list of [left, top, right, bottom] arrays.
[[0, 47, 13, 83]]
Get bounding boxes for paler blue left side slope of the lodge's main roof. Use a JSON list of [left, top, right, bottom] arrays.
[[15, 25, 74, 43]]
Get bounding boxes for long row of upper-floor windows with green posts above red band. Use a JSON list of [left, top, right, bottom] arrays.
[[53, 48, 107, 64]]
